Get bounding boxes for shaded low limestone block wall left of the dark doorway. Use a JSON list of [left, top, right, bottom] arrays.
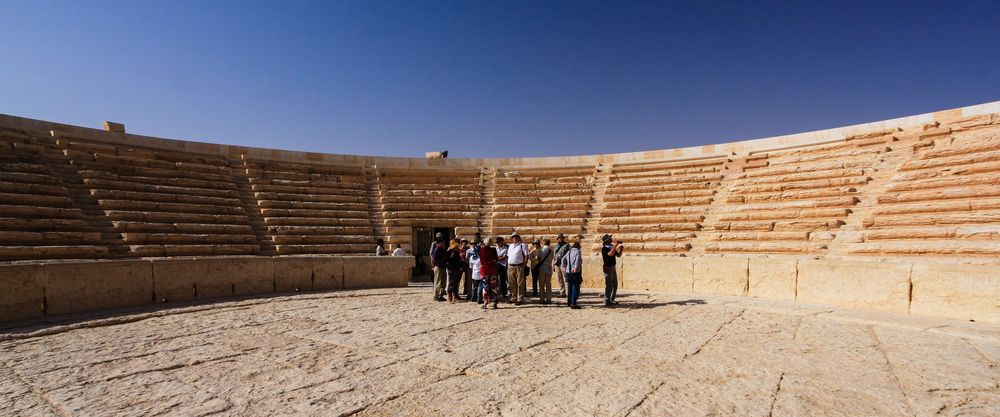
[[0, 255, 414, 322]]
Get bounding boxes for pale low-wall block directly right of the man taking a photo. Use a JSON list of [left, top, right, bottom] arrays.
[[620, 256, 694, 292]]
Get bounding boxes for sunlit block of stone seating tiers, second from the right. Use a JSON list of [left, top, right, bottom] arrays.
[[705, 135, 895, 254]]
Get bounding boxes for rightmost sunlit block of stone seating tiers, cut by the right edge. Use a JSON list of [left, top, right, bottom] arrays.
[[849, 126, 1000, 257]]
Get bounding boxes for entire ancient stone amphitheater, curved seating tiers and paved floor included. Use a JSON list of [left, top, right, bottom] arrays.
[[0, 102, 1000, 416]]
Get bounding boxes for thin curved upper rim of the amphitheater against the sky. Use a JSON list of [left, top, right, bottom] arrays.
[[0, 101, 1000, 168]]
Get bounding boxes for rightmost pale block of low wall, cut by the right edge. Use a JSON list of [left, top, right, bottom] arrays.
[[910, 264, 1000, 323]]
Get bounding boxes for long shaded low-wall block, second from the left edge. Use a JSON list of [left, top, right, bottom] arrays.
[[42, 260, 153, 315]]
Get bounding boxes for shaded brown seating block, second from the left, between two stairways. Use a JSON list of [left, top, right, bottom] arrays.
[[58, 138, 259, 256]]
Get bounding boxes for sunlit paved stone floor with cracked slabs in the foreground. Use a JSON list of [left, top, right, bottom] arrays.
[[0, 287, 1000, 416]]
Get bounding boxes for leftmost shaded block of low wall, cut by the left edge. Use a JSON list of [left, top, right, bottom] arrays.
[[0, 265, 45, 321]]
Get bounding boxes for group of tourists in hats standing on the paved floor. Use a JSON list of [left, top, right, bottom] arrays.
[[420, 233, 623, 309]]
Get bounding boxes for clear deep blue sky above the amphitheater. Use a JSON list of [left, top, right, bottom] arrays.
[[0, 0, 1000, 157]]
